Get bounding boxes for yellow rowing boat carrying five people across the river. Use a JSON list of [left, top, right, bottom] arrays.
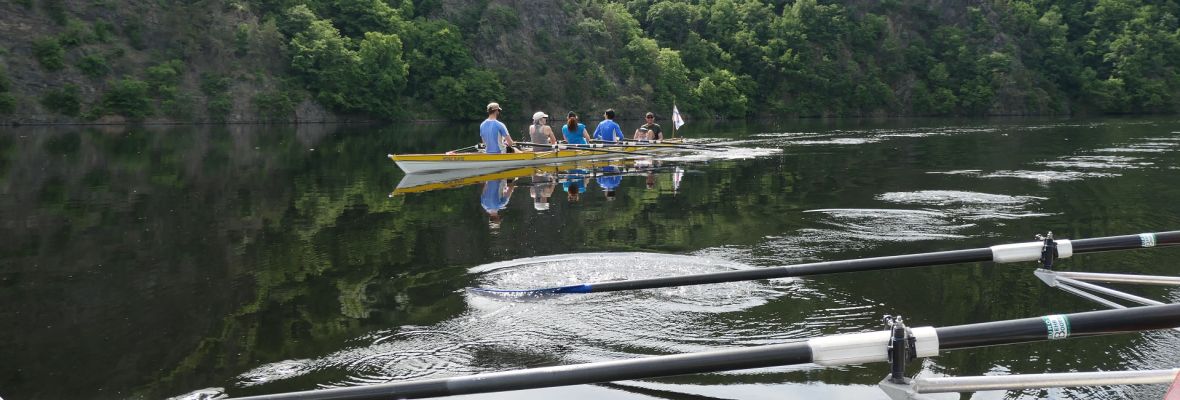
[[389, 140, 683, 173]]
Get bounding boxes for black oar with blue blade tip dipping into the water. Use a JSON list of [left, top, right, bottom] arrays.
[[471, 230, 1180, 295]]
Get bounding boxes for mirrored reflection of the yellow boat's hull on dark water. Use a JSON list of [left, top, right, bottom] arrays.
[[393, 159, 651, 195]]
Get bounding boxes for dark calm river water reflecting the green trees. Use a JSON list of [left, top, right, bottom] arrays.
[[0, 117, 1180, 400]]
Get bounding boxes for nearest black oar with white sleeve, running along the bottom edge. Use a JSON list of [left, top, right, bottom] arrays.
[[230, 304, 1180, 400]]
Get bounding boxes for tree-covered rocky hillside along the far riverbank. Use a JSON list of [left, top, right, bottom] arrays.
[[0, 0, 1180, 123]]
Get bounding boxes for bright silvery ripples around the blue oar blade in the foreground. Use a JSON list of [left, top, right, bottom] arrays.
[[237, 253, 830, 387]]
